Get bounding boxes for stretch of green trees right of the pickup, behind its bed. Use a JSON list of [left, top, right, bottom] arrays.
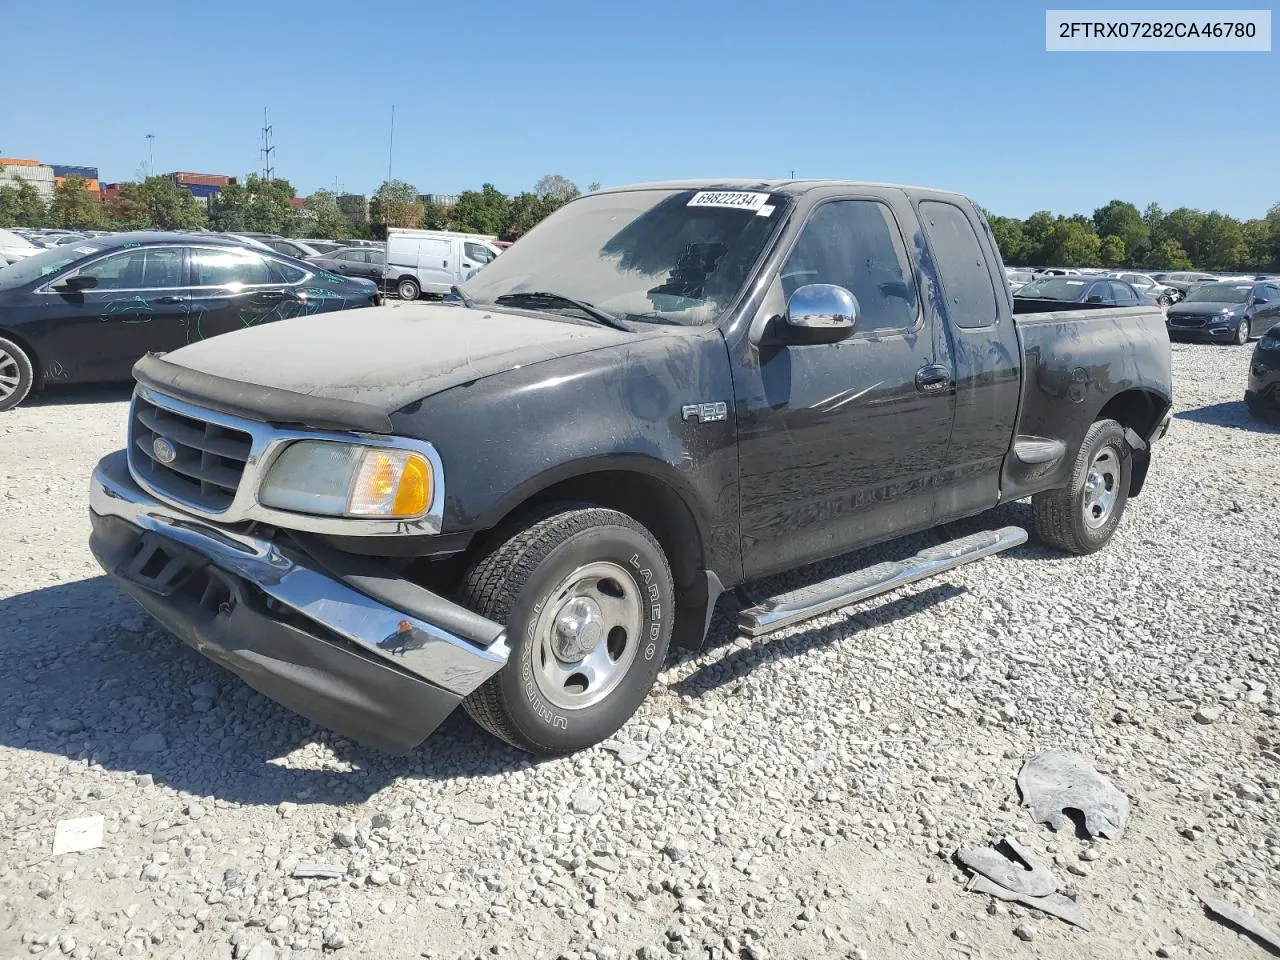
[[987, 200, 1280, 271]]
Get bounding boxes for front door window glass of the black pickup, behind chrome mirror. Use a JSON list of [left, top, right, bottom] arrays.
[[782, 200, 919, 332]]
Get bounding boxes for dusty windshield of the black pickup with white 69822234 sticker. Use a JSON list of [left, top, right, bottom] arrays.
[[461, 189, 790, 325]]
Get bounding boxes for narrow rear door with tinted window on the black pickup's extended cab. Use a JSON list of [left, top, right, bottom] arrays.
[[916, 198, 1021, 522]]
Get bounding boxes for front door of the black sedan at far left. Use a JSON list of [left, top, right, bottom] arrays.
[[40, 247, 189, 381]]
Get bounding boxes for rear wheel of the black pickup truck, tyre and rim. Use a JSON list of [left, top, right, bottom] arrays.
[[1032, 420, 1133, 554]]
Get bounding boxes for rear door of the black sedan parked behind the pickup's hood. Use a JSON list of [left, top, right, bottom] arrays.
[[187, 247, 306, 343]]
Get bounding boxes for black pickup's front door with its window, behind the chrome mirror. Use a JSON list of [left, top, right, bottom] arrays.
[[733, 198, 955, 576]]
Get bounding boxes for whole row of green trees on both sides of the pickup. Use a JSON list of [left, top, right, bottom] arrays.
[[0, 167, 1280, 271]]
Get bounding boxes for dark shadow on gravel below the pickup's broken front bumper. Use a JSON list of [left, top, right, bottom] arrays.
[[0, 576, 536, 805]]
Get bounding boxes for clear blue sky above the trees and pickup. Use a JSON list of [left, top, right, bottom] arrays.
[[0, 0, 1280, 216]]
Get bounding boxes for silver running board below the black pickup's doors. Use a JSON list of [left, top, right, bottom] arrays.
[[737, 526, 1027, 636]]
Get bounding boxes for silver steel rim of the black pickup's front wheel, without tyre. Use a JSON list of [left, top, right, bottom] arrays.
[[529, 561, 641, 710]]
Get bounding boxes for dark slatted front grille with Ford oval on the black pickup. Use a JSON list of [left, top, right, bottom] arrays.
[[129, 394, 252, 513]]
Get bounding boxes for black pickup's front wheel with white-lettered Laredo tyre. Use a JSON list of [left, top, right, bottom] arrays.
[[461, 504, 676, 755]]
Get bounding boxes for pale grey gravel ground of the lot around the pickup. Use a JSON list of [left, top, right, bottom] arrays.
[[0, 346, 1280, 960]]
